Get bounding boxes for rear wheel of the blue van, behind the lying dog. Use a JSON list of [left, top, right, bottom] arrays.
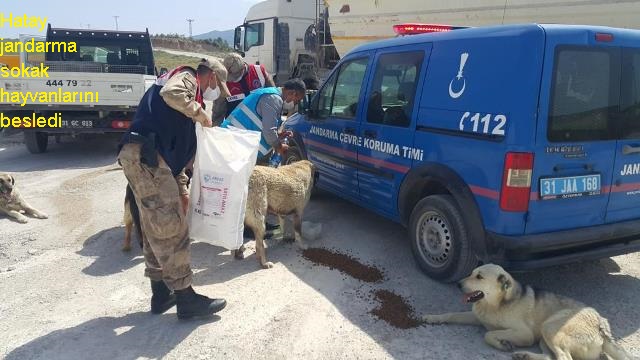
[[409, 195, 478, 282]]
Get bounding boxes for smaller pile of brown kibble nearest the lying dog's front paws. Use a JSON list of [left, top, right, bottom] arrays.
[[371, 290, 421, 329]]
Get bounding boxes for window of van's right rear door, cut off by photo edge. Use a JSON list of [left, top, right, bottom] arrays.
[[620, 49, 640, 139]]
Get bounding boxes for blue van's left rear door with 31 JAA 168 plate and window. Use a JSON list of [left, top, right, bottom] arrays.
[[526, 45, 621, 234]]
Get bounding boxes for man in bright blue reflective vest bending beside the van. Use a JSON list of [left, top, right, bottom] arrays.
[[220, 79, 307, 165]]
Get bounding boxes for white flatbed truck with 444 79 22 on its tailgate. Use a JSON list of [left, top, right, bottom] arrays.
[[0, 24, 156, 153]]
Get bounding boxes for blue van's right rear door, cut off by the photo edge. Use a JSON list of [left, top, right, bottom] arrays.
[[605, 48, 640, 223]]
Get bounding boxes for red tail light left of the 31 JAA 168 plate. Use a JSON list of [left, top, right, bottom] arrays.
[[500, 152, 533, 212]]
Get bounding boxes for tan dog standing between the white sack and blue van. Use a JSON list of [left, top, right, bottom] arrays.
[[236, 160, 315, 269]]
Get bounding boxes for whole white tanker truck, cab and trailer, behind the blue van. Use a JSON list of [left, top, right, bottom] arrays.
[[234, 0, 640, 83]]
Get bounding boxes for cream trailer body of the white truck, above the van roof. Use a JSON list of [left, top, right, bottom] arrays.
[[329, 0, 640, 56]]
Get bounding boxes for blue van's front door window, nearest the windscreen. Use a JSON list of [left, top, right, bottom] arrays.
[[331, 58, 368, 119]]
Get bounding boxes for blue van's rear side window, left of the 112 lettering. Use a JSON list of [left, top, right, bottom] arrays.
[[367, 51, 424, 127]]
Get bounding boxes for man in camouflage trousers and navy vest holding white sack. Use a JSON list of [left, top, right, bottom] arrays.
[[118, 59, 228, 319]]
